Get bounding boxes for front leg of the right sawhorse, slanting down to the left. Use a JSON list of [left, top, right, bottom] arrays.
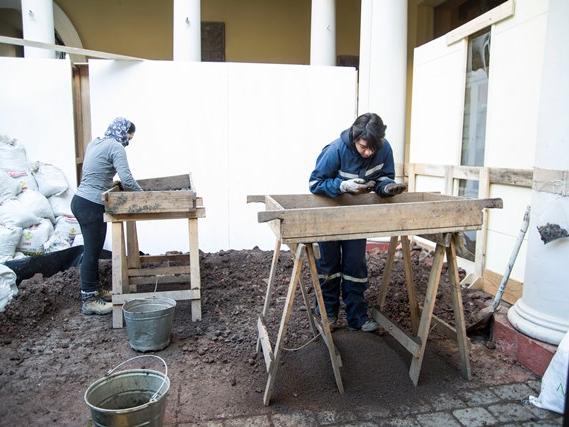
[[409, 245, 445, 386]]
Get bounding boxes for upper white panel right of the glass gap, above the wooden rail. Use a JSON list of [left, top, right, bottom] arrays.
[[485, 1, 547, 168]]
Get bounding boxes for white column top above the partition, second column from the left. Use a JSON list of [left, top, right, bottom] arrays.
[[173, 0, 202, 62]]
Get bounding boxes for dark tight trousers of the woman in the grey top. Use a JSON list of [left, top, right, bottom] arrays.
[[71, 196, 107, 292]]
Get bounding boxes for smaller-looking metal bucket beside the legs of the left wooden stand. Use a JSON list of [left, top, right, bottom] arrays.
[[122, 297, 176, 352]]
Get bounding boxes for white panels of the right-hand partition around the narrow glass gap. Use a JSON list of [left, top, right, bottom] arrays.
[[410, 0, 548, 281]]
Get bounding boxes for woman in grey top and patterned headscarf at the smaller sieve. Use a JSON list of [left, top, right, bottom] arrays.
[[71, 117, 142, 314]]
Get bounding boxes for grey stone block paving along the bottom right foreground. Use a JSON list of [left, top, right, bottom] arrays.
[[177, 380, 563, 427]]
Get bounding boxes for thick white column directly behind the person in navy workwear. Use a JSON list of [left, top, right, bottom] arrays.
[[358, 0, 407, 169]]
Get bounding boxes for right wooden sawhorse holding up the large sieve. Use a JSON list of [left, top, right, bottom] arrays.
[[371, 233, 471, 385]]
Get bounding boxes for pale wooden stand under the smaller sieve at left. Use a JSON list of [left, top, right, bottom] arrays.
[[105, 212, 205, 328]]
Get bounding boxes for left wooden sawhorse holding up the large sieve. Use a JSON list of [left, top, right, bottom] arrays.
[[257, 239, 344, 405]]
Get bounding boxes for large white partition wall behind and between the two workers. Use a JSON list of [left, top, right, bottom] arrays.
[[89, 60, 356, 253]]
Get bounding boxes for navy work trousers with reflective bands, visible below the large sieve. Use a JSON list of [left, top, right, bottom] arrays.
[[316, 239, 368, 329]]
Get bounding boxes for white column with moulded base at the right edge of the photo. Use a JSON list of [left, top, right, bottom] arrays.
[[508, 0, 569, 344]]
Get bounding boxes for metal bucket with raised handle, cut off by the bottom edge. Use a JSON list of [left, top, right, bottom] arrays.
[[85, 355, 170, 427]]
